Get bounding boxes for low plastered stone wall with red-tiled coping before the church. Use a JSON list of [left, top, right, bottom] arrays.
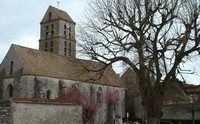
[[11, 99, 82, 124]]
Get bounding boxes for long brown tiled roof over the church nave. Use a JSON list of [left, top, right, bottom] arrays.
[[11, 45, 124, 87]]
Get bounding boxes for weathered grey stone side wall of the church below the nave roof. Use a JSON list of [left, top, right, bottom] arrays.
[[3, 75, 125, 124]]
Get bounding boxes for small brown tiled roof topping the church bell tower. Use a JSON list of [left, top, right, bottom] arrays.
[[41, 6, 75, 24]]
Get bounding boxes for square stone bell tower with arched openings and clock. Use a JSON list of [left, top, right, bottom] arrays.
[[39, 6, 76, 58]]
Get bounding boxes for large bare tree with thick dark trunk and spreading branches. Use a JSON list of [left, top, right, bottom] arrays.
[[78, 0, 200, 123]]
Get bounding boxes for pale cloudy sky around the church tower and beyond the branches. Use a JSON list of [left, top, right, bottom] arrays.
[[0, 0, 200, 84]]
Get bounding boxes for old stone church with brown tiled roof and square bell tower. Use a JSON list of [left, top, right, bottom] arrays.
[[0, 6, 125, 124]]
